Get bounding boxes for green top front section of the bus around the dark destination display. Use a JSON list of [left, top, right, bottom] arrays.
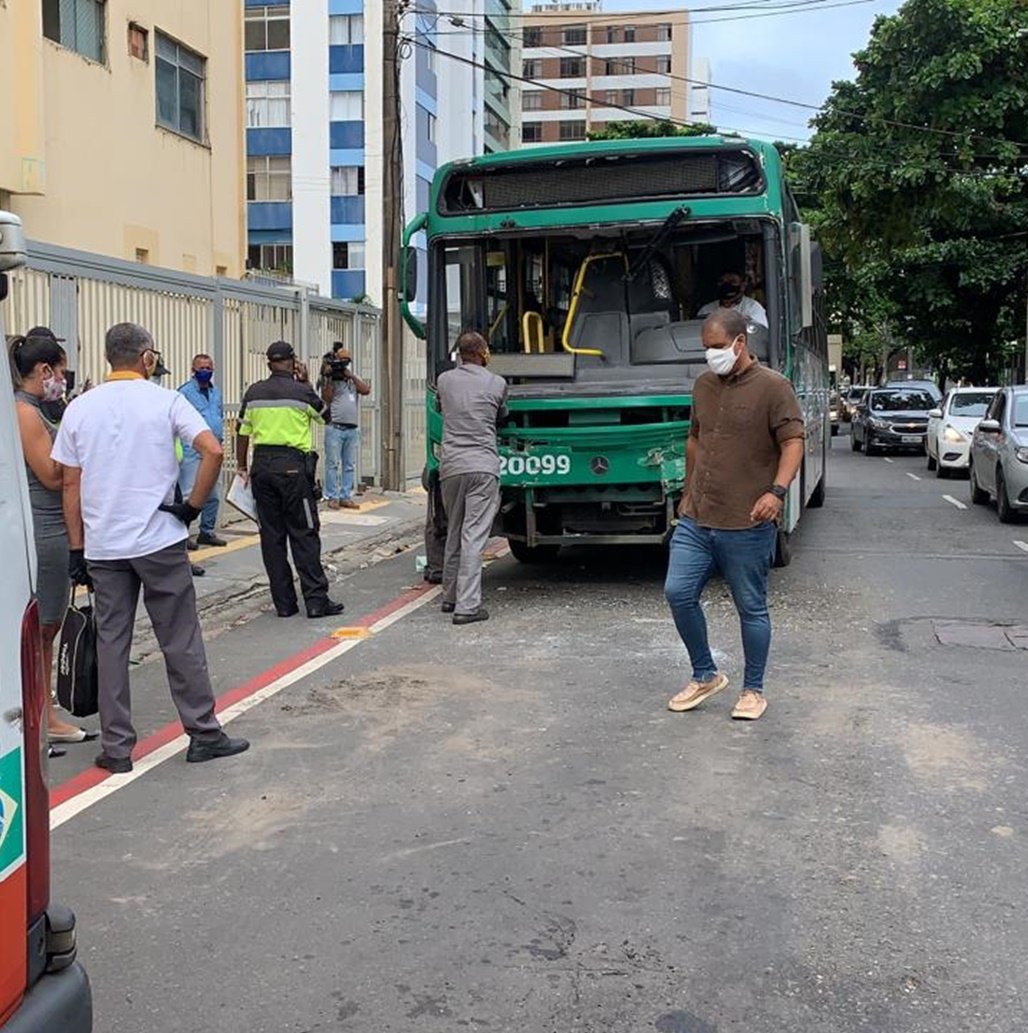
[[427, 135, 782, 237]]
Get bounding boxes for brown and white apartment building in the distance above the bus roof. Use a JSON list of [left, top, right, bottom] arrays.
[[522, 0, 690, 146]]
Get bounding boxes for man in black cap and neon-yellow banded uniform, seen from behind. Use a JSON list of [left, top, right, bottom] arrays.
[[236, 341, 343, 617]]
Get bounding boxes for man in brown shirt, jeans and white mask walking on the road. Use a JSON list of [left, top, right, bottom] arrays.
[[664, 309, 804, 721]]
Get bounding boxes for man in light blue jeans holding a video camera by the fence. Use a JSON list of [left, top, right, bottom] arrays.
[[321, 341, 371, 509]]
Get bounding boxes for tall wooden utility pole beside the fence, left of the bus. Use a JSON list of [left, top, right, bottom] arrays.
[[382, 0, 406, 491]]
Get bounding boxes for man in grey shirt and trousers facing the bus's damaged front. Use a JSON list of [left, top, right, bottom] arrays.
[[436, 331, 507, 624]]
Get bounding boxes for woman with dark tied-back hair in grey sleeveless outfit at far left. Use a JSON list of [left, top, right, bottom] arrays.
[[10, 336, 96, 743]]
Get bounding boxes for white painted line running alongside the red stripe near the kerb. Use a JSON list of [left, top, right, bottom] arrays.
[[50, 586, 442, 831]]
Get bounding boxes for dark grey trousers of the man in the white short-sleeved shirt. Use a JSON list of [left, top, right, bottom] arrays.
[[89, 541, 221, 757]]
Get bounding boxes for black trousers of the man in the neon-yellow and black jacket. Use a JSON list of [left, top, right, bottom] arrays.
[[250, 448, 329, 613]]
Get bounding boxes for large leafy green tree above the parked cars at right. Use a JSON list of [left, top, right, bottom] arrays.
[[805, 0, 1028, 382]]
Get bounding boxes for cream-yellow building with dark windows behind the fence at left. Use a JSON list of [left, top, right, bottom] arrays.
[[0, 0, 246, 277]]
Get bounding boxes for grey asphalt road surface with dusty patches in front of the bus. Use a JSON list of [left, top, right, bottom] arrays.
[[54, 436, 1028, 1033]]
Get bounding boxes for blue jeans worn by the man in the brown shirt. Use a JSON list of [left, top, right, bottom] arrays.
[[664, 517, 776, 692]]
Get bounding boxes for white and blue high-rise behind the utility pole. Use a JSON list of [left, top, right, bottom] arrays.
[[245, 0, 520, 304]]
